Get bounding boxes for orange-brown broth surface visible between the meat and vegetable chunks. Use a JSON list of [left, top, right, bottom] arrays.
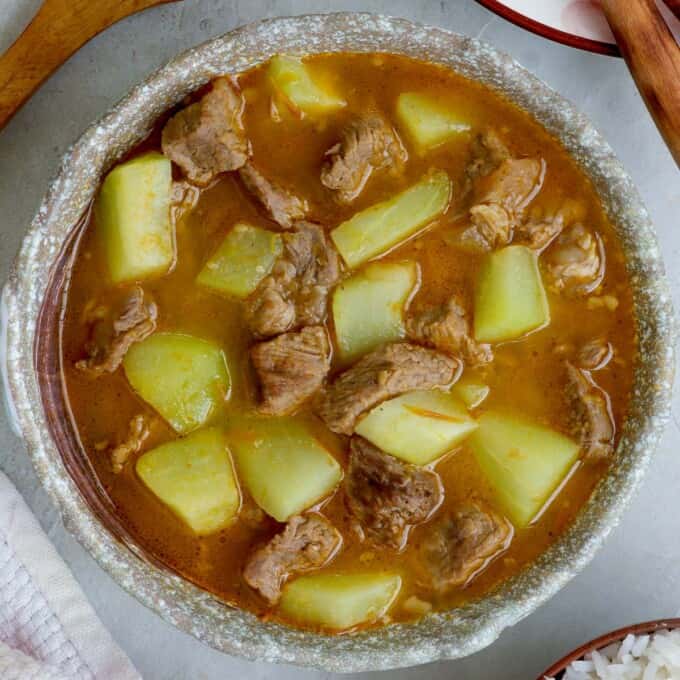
[[62, 54, 636, 632]]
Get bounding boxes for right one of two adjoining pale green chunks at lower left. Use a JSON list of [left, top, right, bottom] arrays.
[[229, 418, 342, 522]]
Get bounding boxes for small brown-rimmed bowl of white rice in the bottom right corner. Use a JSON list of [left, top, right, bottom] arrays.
[[538, 619, 680, 680]]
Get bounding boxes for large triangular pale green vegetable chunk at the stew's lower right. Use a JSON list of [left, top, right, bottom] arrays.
[[469, 412, 580, 527]]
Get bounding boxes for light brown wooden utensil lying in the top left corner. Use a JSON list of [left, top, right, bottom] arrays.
[[0, 0, 175, 129]]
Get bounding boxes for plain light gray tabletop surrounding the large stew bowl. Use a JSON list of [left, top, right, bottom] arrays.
[[0, 0, 680, 680]]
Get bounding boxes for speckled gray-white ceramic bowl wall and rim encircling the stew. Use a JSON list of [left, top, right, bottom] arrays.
[[3, 14, 673, 671]]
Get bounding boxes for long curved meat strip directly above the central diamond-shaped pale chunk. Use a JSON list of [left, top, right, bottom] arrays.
[[317, 342, 461, 434]]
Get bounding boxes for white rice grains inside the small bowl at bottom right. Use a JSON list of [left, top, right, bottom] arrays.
[[545, 630, 680, 680]]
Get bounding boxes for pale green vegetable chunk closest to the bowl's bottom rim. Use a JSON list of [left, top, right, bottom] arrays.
[[279, 572, 401, 630]]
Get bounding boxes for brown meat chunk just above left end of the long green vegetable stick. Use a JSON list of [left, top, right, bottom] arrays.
[[321, 114, 406, 203]]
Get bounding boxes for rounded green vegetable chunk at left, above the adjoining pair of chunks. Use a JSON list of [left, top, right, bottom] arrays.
[[123, 333, 231, 434]]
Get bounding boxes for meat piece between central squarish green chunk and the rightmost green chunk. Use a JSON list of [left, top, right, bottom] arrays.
[[406, 298, 493, 366]]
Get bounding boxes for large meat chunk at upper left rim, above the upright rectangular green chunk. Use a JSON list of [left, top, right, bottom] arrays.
[[161, 78, 250, 186]]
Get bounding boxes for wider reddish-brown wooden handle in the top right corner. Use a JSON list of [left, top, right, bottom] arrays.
[[601, 0, 680, 166]]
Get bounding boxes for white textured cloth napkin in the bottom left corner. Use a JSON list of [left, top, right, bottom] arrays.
[[0, 472, 141, 680]]
